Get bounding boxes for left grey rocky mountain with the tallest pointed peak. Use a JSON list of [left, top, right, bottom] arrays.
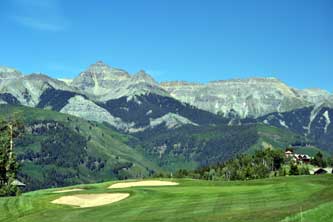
[[0, 62, 205, 132]]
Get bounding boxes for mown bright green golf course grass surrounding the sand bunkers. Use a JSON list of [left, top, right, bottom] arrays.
[[0, 175, 333, 222]]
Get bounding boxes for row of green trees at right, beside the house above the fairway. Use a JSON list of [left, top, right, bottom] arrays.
[[165, 149, 332, 181]]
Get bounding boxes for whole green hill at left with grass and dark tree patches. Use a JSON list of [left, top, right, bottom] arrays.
[[0, 105, 159, 189]]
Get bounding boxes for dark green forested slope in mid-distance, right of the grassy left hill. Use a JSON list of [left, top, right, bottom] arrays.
[[130, 124, 304, 171]]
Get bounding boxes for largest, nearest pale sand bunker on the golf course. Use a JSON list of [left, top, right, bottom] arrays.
[[51, 193, 129, 208]]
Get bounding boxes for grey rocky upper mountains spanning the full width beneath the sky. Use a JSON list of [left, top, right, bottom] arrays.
[[0, 61, 333, 128]]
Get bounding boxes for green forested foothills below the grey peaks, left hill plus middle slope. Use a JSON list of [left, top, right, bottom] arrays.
[[0, 104, 322, 190]]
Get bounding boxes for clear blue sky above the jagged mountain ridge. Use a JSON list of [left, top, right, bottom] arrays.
[[0, 0, 333, 92]]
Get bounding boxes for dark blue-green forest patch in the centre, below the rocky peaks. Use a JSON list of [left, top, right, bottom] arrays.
[[98, 94, 228, 132]]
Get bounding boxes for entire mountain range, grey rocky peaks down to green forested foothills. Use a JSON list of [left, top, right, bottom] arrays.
[[0, 61, 333, 188]]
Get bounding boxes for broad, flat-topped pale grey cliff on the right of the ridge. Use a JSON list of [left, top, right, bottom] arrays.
[[161, 78, 332, 118]]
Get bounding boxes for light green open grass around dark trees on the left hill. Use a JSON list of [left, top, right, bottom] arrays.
[[0, 105, 159, 189]]
